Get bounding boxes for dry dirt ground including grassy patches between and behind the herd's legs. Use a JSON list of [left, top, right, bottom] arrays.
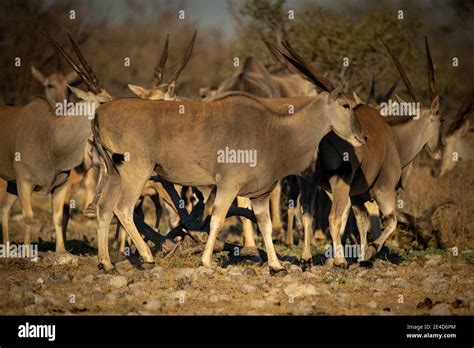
[[0, 164, 474, 315]]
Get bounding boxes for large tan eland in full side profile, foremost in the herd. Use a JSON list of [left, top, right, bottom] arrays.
[[93, 41, 365, 273]]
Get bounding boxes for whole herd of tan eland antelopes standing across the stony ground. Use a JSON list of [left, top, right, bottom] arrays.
[[0, 28, 474, 274]]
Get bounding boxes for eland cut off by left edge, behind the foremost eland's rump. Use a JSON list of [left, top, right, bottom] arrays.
[[0, 32, 112, 252]]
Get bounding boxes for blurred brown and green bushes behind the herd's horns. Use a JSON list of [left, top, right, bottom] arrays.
[[0, 0, 474, 119]]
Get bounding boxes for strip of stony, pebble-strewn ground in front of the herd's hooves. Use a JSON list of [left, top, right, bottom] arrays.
[[0, 239, 474, 315]]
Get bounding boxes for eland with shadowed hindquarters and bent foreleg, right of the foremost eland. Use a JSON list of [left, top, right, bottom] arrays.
[[268, 37, 442, 265]]
